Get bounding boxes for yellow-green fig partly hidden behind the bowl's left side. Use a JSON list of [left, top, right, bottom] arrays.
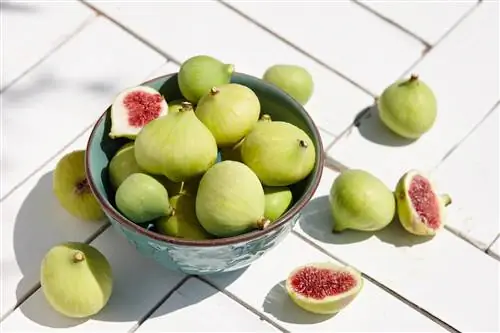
[[52, 150, 104, 221]]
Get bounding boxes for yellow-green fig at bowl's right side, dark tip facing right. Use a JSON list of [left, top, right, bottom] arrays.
[[241, 121, 316, 186]]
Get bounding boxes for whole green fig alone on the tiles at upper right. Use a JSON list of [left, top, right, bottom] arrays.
[[377, 75, 437, 139]]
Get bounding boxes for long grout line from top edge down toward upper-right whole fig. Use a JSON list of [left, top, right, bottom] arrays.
[[217, 0, 375, 96]]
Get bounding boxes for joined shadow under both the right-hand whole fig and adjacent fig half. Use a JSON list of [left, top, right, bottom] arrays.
[[299, 196, 432, 247]]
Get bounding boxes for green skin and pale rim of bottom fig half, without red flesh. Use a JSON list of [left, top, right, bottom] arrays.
[[285, 262, 364, 315]]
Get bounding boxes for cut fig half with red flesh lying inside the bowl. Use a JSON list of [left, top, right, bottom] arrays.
[[109, 86, 168, 139]]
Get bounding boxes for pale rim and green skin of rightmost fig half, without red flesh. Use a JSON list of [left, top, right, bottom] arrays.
[[394, 170, 452, 236]]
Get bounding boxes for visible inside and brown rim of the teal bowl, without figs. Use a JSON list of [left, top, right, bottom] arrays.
[[86, 73, 324, 245]]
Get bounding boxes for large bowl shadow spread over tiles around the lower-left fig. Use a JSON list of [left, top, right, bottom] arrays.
[[14, 171, 246, 328]]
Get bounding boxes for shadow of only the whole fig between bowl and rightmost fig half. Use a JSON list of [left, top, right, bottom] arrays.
[[298, 195, 373, 245]]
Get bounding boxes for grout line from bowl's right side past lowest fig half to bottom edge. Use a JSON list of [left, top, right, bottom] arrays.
[[292, 230, 461, 333]]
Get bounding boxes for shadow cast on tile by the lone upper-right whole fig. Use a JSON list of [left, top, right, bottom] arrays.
[[353, 104, 416, 147]]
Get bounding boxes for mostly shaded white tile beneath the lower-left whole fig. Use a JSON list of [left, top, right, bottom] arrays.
[[2, 227, 184, 332]]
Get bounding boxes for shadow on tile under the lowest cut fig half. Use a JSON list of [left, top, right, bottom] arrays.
[[262, 280, 335, 325]]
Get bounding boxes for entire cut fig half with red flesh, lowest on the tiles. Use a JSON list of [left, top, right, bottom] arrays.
[[286, 262, 363, 314]]
